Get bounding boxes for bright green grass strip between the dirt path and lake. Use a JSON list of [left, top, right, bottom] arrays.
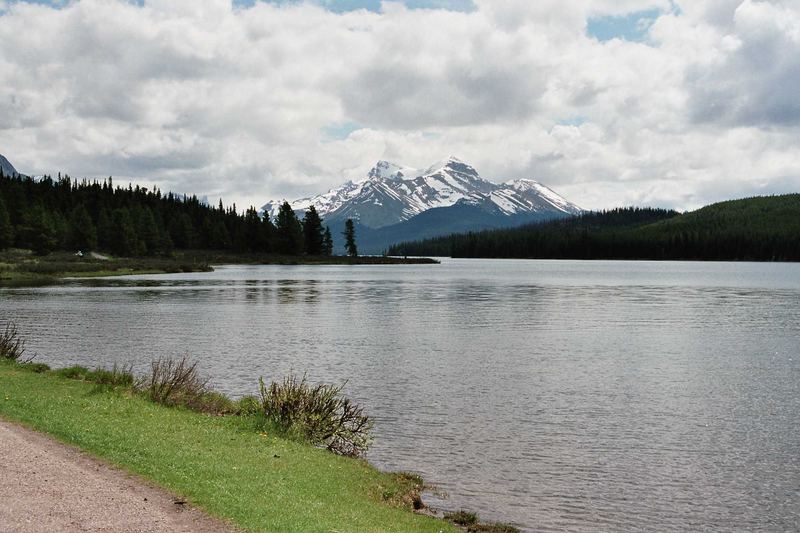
[[0, 361, 457, 532]]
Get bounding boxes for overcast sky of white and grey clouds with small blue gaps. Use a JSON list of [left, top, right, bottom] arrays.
[[0, 0, 800, 209]]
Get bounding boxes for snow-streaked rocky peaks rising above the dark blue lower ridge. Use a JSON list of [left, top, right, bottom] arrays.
[[262, 157, 581, 228]]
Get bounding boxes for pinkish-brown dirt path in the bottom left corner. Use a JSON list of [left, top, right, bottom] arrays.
[[0, 420, 233, 533]]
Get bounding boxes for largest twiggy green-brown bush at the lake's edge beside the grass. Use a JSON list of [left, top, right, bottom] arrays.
[[259, 374, 372, 456]]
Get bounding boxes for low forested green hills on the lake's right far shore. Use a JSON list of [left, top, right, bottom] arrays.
[[388, 194, 800, 261]]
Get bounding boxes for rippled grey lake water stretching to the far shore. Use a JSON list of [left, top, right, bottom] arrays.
[[0, 260, 800, 531]]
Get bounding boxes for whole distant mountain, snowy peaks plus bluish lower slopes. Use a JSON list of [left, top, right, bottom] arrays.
[[261, 157, 582, 253]]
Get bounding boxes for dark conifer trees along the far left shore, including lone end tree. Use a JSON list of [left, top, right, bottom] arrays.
[[0, 170, 357, 256]]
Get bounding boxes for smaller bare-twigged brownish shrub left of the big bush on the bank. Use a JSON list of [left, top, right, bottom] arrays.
[[136, 356, 211, 409]]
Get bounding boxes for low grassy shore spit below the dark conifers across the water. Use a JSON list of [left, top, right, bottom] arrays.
[[0, 249, 437, 287]]
